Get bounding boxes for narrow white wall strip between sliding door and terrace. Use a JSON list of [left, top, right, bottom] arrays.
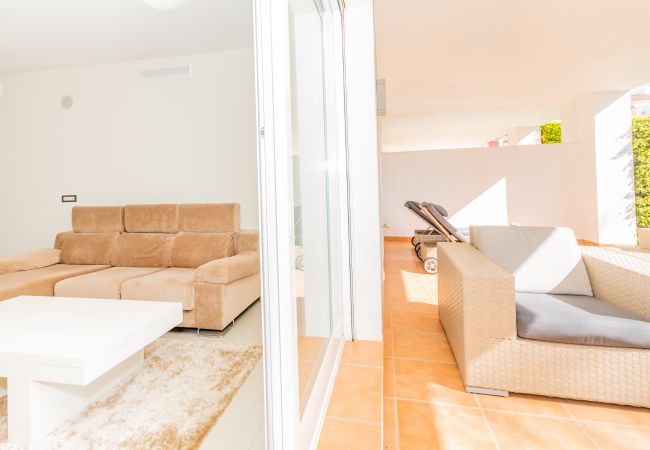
[[344, 0, 383, 340]]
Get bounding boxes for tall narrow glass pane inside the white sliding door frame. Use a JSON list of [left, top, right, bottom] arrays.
[[289, 0, 338, 411]]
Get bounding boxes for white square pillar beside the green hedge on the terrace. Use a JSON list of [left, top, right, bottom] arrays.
[[562, 92, 637, 245]]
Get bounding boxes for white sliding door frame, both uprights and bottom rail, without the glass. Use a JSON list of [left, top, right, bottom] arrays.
[[253, 0, 352, 450]]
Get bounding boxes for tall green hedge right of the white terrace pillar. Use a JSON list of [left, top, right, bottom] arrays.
[[632, 117, 650, 228]]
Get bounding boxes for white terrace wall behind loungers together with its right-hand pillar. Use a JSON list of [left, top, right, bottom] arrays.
[[382, 92, 636, 245]]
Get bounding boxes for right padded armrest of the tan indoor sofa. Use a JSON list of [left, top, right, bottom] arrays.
[[194, 252, 260, 284]]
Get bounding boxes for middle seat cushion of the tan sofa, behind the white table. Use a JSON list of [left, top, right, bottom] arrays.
[[54, 267, 163, 299]]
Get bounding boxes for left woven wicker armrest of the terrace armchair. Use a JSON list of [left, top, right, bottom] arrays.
[[438, 243, 517, 342]]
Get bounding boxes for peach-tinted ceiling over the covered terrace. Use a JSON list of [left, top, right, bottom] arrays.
[[375, 0, 650, 151]]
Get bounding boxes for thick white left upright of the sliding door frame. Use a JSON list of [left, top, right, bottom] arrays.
[[253, 0, 300, 450]]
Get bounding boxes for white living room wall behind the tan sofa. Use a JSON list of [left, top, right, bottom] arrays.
[[0, 49, 258, 256]]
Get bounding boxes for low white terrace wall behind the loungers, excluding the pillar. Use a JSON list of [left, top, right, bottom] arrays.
[[382, 144, 582, 237]]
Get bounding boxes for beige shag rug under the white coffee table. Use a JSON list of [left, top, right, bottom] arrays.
[[0, 338, 262, 450]]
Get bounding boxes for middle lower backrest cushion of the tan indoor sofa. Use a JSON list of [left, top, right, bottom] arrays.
[[111, 233, 175, 267]]
